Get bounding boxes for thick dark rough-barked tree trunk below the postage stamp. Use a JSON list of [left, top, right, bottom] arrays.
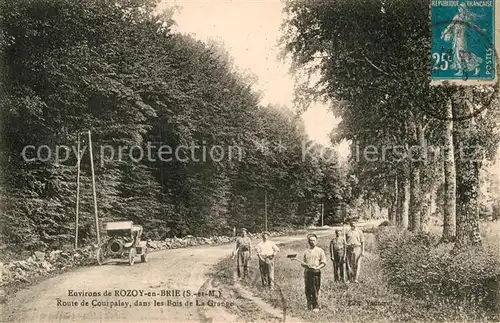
[[454, 91, 482, 250]]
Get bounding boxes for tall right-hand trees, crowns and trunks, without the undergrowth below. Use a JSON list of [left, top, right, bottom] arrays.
[[283, 0, 500, 248]]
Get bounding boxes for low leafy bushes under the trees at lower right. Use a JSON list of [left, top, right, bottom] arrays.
[[377, 228, 500, 318]]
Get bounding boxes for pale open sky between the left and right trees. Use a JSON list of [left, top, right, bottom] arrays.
[[158, 0, 339, 146]]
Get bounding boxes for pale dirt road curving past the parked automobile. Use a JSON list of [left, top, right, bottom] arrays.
[[0, 230, 333, 323]]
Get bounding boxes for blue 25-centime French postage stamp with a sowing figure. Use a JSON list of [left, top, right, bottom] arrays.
[[430, 0, 500, 85]]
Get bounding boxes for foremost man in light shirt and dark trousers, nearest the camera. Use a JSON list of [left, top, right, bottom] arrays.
[[302, 233, 326, 312]]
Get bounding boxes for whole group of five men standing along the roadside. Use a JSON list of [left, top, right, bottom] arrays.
[[233, 222, 365, 311]]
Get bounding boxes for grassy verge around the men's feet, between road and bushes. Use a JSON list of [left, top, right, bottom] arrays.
[[214, 234, 484, 322]]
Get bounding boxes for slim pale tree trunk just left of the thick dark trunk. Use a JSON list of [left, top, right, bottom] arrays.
[[441, 100, 457, 242]]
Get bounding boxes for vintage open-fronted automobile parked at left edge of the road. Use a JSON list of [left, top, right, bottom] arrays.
[[96, 221, 148, 266]]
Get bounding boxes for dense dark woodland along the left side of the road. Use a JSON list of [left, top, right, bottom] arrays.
[[0, 0, 347, 249]]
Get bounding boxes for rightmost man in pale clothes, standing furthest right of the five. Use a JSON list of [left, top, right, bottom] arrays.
[[346, 221, 365, 283]]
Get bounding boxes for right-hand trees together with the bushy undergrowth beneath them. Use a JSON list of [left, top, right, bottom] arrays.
[[283, 0, 500, 321]]
